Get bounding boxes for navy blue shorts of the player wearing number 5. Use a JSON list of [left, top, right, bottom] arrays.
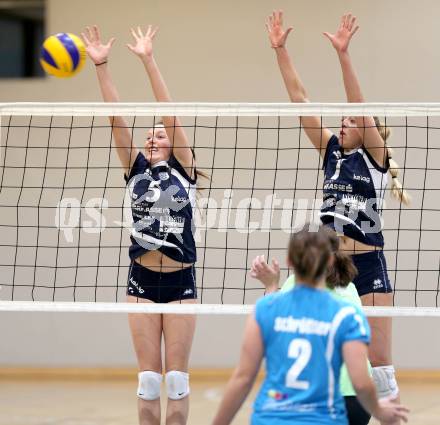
[[127, 261, 197, 303]]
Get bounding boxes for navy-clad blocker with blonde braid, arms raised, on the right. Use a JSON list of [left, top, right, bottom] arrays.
[[266, 11, 409, 420]]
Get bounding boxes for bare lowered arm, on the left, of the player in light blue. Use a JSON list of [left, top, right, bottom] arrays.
[[212, 314, 263, 425]]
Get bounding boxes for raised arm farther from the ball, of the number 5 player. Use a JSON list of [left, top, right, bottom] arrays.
[[127, 25, 195, 176]]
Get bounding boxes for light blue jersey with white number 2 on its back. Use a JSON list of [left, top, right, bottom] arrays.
[[252, 284, 370, 425]]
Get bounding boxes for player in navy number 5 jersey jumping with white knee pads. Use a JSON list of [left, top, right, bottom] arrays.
[[83, 26, 204, 425]]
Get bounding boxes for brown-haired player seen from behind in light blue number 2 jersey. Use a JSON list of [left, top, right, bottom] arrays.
[[213, 226, 407, 425]]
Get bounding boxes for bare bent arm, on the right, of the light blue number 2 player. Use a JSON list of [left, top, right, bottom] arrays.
[[342, 340, 408, 424]]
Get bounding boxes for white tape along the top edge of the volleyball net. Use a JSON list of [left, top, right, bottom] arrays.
[[0, 102, 440, 117]]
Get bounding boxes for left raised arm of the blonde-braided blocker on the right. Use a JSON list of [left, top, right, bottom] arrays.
[[266, 10, 332, 155]]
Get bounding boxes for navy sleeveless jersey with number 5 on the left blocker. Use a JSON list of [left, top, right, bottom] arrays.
[[124, 152, 196, 263]]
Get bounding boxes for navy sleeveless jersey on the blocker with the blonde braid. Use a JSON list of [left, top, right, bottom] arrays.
[[320, 135, 388, 247]]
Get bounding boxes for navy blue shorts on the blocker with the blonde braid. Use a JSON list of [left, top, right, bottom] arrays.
[[351, 250, 393, 296]]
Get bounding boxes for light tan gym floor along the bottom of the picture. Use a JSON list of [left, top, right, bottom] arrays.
[[0, 378, 440, 425]]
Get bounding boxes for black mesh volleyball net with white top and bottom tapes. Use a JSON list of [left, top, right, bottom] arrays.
[[0, 103, 440, 316]]
